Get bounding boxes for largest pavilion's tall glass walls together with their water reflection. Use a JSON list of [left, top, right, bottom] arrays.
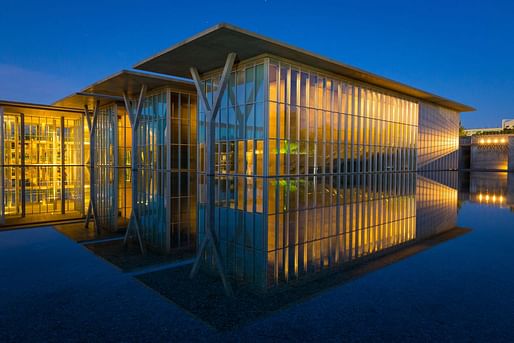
[[198, 59, 418, 287]]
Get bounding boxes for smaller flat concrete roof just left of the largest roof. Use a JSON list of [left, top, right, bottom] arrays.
[[54, 70, 195, 108]]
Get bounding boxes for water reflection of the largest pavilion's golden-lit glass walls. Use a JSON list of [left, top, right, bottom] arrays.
[[198, 172, 458, 290]]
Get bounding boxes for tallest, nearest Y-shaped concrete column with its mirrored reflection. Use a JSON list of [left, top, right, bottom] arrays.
[[190, 53, 236, 295]]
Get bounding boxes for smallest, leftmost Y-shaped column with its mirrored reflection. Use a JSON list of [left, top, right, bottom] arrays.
[[84, 100, 100, 233]]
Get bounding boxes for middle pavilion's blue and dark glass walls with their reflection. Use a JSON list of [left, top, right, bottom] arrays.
[[136, 89, 197, 252]]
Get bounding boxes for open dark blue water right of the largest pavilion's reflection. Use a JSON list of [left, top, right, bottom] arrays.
[[229, 173, 514, 342]]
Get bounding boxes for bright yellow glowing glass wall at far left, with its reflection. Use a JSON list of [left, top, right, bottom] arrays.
[[0, 111, 84, 220]]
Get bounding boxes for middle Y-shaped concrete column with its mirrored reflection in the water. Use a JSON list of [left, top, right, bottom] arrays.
[[123, 85, 147, 254]]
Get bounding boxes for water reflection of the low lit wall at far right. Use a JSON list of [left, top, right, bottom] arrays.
[[459, 172, 514, 211]]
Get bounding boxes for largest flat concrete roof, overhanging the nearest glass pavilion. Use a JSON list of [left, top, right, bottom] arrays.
[[134, 23, 475, 112]]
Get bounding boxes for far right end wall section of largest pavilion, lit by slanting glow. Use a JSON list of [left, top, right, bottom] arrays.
[[417, 102, 459, 171]]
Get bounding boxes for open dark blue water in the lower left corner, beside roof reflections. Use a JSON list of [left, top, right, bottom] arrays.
[[0, 228, 214, 342]]
